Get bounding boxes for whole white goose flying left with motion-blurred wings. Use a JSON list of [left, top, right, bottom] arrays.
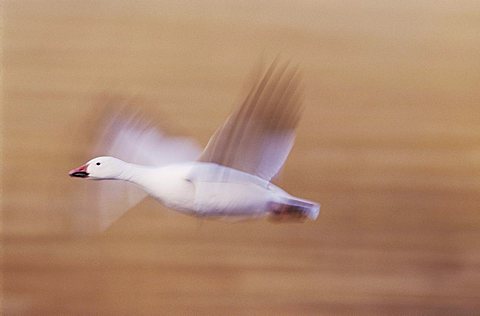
[[69, 62, 320, 229]]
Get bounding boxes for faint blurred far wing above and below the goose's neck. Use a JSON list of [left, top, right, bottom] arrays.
[[79, 105, 200, 231]]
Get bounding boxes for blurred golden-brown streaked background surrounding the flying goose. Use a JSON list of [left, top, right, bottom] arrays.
[[1, 0, 480, 315]]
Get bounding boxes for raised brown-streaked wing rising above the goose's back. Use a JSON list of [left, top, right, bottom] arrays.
[[199, 62, 302, 181]]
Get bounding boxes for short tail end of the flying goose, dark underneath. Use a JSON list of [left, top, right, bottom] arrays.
[[269, 197, 320, 221]]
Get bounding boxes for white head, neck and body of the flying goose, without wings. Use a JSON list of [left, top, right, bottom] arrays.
[[75, 157, 319, 219]]
